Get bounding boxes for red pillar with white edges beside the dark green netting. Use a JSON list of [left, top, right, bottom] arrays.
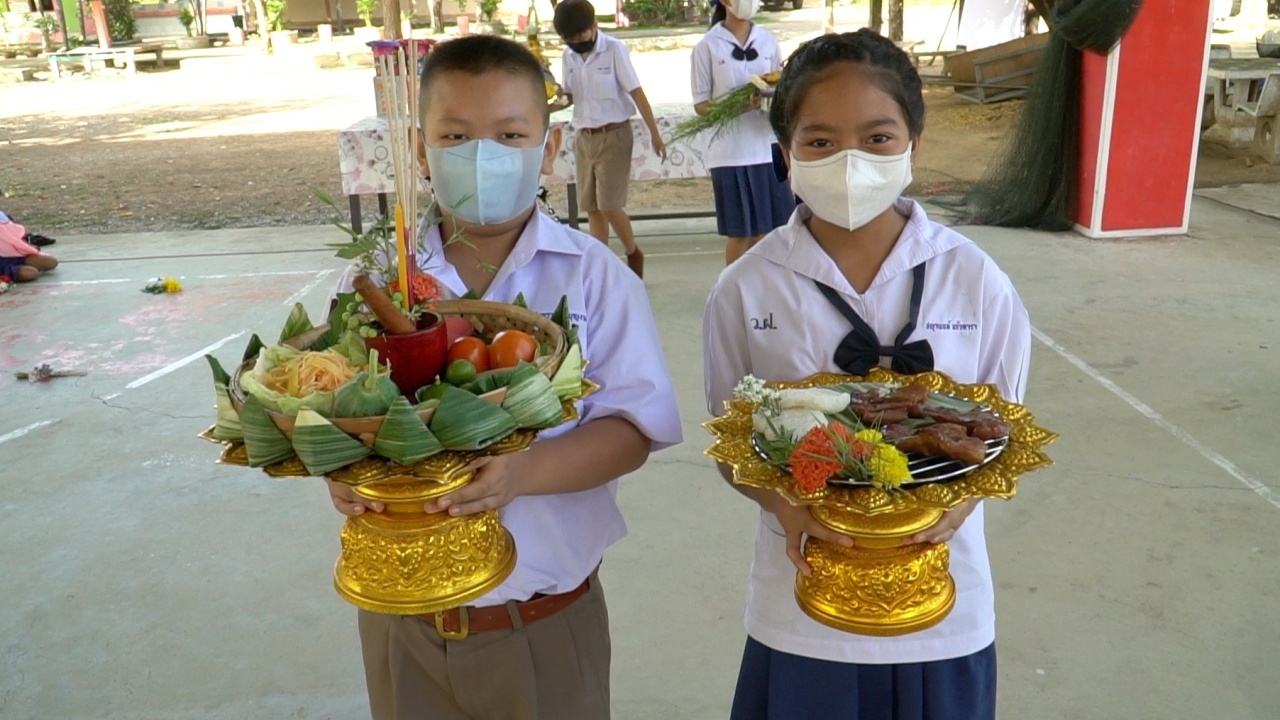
[[1075, 0, 1212, 237]]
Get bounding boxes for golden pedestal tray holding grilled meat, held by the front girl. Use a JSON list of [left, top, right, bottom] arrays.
[[704, 368, 1057, 635]]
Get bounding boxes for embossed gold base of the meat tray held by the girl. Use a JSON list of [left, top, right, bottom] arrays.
[[796, 538, 956, 637]]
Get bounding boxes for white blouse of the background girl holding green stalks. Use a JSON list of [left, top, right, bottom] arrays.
[[692, 23, 782, 168]]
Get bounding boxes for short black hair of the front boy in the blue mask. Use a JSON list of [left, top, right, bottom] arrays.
[[419, 35, 550, 124]]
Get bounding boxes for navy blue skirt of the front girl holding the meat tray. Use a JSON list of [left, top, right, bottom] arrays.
[[730, 638, 996, 720]]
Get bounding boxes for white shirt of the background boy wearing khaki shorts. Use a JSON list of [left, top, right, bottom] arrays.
[[561, 29, 640, 129]]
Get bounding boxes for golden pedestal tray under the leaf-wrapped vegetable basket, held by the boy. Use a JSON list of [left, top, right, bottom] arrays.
[[200, 378, 599, 615]]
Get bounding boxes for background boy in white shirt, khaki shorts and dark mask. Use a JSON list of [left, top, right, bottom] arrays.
[[553, 0, 667, 277]]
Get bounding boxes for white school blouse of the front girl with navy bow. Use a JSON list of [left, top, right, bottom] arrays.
[[703, 199, 1030, 664]]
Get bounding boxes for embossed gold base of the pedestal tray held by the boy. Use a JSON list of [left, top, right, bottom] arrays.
[[333, 473, 516, 615]]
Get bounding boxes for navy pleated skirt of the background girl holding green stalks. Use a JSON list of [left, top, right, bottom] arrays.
[[712, 163, 796, 237]]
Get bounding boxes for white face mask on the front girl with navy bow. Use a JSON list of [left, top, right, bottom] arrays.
[[791, 143, 914, 231]]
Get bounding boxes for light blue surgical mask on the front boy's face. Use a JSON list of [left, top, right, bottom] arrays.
[[426, 138, 547, 225]]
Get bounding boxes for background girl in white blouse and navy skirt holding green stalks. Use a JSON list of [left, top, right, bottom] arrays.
[[692, 0, 795, 263]]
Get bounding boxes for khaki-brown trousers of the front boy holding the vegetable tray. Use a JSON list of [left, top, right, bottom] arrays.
[[360, 575, 611, 720]]
